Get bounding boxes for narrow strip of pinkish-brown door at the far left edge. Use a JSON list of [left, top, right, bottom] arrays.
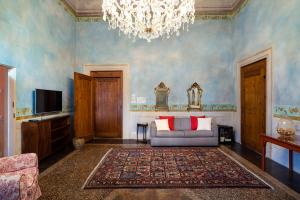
[[0, 66, 8, 157]]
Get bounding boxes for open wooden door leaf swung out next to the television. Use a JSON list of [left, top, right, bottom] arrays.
[[74, 72, 94, 140]]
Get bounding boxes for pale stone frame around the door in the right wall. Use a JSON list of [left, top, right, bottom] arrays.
[[236, 48, 274, 148]]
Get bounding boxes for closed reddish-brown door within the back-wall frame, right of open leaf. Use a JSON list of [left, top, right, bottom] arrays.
[[91, 71, 123, 138]]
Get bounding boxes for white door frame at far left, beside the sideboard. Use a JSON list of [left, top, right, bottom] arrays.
[[0, 64, 16, 156]]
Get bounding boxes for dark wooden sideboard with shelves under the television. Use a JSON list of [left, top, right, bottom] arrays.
[[21, 116, 71, 160]]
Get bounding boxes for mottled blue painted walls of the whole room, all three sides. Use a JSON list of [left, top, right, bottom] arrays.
[[0, 0, 300, 172]]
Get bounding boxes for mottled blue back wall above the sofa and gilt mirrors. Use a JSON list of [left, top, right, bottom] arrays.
[[76, 20, 235, 105]]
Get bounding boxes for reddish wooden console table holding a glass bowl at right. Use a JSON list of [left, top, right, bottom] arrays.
[[260, 134, 300, 172]]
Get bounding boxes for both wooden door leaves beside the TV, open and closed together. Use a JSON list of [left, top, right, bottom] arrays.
[[74, 66, 127, 140]]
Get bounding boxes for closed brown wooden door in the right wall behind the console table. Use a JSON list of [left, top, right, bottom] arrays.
[[241, 59, 266, 153]]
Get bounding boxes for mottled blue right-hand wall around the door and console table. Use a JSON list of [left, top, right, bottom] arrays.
[[233, 0, 300, 172]]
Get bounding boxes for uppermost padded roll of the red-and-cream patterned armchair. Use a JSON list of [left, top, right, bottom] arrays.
[[0, 153, 38, 173]]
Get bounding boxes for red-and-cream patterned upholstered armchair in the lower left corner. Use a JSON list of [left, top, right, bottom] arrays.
[[0, 153, 41, 200]]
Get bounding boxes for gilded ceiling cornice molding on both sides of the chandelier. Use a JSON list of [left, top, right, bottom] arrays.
[[57, 0, 250, 22]]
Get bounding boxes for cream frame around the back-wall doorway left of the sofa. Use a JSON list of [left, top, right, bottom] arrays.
[[83, 64, 131, 138]]
